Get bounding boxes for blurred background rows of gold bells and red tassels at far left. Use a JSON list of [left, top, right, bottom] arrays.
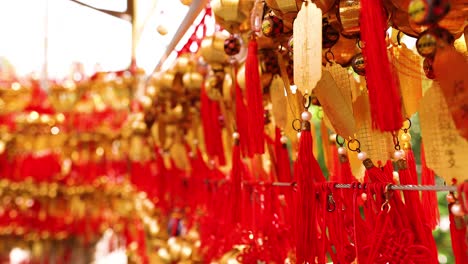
[[0, 70, 206, 262]]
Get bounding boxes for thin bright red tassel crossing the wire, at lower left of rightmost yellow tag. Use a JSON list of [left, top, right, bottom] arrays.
[[421, 145, 440, 230]]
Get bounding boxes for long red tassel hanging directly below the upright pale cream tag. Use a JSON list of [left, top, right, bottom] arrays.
[[294, 121, 325, 263]]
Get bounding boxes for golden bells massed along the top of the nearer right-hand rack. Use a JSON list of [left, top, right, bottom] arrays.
[[152, 0, 467, 144]]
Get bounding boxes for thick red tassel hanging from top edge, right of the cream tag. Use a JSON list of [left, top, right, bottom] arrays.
[[360, 0, 402, 131]]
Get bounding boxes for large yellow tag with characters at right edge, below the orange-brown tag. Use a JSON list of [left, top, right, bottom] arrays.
[[419, 82, 468, 184]]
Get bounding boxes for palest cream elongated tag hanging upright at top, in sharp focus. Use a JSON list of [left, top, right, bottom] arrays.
[[293, 1, 322, 94]]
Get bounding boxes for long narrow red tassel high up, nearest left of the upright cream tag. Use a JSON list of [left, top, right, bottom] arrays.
[[244, 39, 265, 154]]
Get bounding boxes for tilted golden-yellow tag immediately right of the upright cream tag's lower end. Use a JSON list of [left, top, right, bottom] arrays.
[[314, 70, 356, 138]]
